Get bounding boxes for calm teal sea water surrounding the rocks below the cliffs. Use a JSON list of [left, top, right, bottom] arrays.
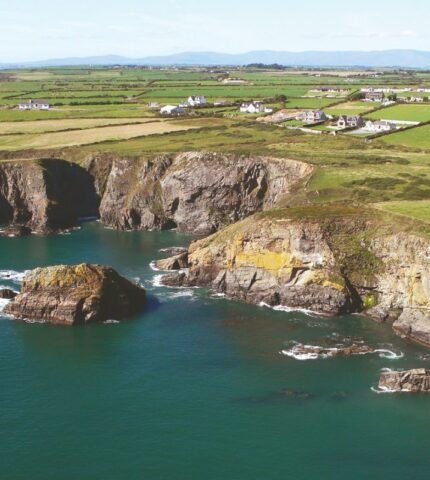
[[0, 223, 430, 480]]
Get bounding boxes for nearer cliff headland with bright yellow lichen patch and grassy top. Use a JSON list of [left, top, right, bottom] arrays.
[[159, 205, 430, 346]]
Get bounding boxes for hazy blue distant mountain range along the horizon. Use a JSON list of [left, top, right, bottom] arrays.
[[0, 50, 430, 69]]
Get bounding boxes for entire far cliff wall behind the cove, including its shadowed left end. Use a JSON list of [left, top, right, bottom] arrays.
[[0, 152, 312, 234]]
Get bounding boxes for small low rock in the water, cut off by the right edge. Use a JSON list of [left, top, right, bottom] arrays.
[[379, 368, 430, 393]]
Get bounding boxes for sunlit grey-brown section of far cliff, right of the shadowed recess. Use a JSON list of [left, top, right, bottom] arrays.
[[95, 153, 312, 234]]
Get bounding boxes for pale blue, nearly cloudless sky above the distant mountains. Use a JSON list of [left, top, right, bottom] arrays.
[[0, 0, 430, 63]]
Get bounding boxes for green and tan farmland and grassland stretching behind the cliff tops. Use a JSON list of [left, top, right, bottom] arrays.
[[0, 67, 430, 226]]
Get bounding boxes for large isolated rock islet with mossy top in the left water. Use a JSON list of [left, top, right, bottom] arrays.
[[4, 264, 146, 325]]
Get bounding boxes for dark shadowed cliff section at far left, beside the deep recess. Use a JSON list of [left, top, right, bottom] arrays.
[[0, 159, 98, 233]]
